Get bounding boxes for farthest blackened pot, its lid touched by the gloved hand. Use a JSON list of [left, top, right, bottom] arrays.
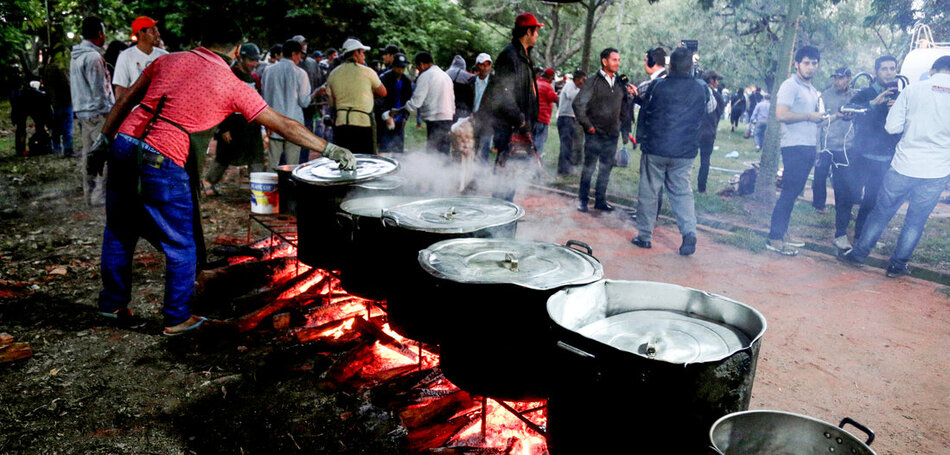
[[292, 155, 399, 270]]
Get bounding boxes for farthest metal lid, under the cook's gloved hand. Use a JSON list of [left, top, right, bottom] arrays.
[[293, 154, 399, 186]]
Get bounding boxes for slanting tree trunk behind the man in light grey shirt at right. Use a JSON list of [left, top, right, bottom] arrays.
[[753, 0, 802, 206]]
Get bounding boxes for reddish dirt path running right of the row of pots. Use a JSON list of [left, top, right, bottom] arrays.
[[516, 191, 950, 455]]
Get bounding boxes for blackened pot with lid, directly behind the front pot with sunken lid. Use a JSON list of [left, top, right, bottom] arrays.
[[417, 239, 604, 400]]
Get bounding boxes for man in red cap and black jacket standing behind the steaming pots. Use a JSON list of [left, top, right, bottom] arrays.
[[478, 13, 544, 201]]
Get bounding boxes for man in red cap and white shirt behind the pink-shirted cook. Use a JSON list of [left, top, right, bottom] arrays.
[[112, 16, 168, 99]]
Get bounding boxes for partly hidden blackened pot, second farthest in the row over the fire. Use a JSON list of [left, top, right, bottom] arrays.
[[338, 193, 422, 300]]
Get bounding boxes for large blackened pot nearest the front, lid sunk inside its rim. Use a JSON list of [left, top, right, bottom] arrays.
[[547, 280, 766, 454]]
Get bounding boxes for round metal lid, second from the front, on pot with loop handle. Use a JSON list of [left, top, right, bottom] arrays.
[[419, 238, 604, 290]]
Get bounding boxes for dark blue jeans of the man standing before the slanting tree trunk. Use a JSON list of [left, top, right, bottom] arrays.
[[769, 145, 815, 240]]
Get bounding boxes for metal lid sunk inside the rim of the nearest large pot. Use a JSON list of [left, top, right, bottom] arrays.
[[577, 310, 750, 364]]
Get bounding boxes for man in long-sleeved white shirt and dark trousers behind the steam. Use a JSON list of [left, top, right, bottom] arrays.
[[390, 52, 455, 155]]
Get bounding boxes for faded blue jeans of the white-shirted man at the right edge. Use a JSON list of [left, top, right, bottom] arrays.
[[851, 168, 950, 269]]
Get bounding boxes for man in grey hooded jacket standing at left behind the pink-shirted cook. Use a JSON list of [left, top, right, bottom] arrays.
[[69, 16, 115, 206]]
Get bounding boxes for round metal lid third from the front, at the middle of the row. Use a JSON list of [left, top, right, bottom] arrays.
[[383, 197, 524, 234]]
